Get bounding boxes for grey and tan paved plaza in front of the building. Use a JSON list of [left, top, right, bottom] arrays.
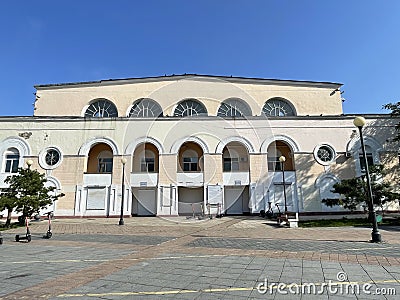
[[0, 217, 400, 299]]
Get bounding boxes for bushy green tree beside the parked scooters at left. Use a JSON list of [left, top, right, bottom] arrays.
[[0, 168, 64, 225]]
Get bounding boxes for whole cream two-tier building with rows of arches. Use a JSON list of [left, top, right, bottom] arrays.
[[0, 75, 399, 217]]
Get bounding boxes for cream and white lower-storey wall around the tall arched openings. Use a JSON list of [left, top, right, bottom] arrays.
[[0, 116, 399, 216]]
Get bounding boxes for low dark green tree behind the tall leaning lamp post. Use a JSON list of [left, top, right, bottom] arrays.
[[322, 165, 400, 211]]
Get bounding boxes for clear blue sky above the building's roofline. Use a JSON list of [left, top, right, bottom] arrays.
[[0, 0, 400, 116]]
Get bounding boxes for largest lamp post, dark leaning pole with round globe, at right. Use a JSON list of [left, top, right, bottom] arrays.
[[353, 117, 382, 243]]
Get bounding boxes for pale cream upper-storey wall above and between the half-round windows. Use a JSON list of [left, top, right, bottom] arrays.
[[34, 76, 343, 117]]
